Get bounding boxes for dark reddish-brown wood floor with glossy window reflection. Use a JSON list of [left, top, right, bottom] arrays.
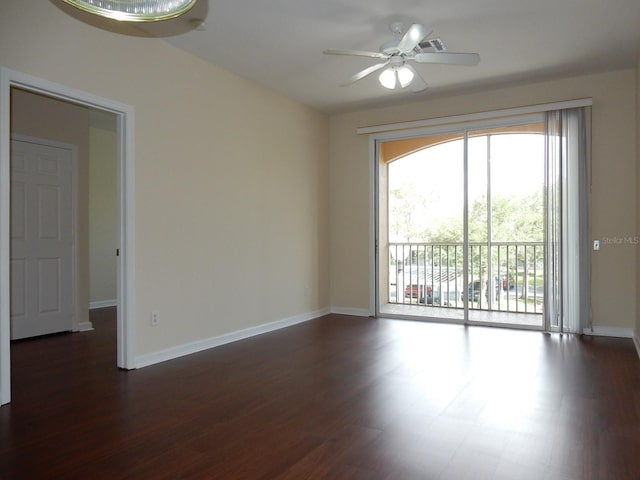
[[0, 310, 640, 480]]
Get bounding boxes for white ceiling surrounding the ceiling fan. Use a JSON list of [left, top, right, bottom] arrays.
[[143, 0, 640, 113]]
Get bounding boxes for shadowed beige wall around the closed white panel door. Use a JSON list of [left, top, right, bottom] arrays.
[[11, 89, 89, 323]]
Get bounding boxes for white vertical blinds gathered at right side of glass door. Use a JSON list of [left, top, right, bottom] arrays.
[[544, 108, 591, 333]]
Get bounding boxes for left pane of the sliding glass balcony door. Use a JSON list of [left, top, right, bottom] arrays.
[[378, 132, 465, 321]]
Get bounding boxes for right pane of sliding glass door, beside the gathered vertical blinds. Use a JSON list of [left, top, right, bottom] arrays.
[[465, 122, 545, 328]]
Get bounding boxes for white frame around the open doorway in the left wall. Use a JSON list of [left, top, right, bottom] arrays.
[[0, 67, 136, 405]]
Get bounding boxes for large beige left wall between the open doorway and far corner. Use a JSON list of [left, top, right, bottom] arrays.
[[0, 0, 329, 355]]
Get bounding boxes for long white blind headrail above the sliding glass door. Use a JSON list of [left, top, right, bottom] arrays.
[[356, 98, 593, 135]]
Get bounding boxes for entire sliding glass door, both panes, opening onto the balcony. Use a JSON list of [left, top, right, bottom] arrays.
[[376, 115, 545, 328]]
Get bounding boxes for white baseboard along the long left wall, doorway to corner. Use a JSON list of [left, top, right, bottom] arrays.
[[135, 308, 330, 368]]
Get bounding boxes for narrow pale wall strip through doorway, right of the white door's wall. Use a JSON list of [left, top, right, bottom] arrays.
[[89, 112, 118, 306]]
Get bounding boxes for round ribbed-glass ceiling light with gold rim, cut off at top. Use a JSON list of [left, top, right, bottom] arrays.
[[63, 0, 198, 22]]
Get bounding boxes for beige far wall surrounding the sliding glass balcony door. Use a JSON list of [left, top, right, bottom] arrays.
[[330, 70, 637, 329]]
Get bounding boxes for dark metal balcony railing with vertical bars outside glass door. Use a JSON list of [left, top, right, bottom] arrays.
[[388, 242, 544, 314]]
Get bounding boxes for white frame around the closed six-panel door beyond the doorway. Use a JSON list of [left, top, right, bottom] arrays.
[[9, 134, 80, 332]]
